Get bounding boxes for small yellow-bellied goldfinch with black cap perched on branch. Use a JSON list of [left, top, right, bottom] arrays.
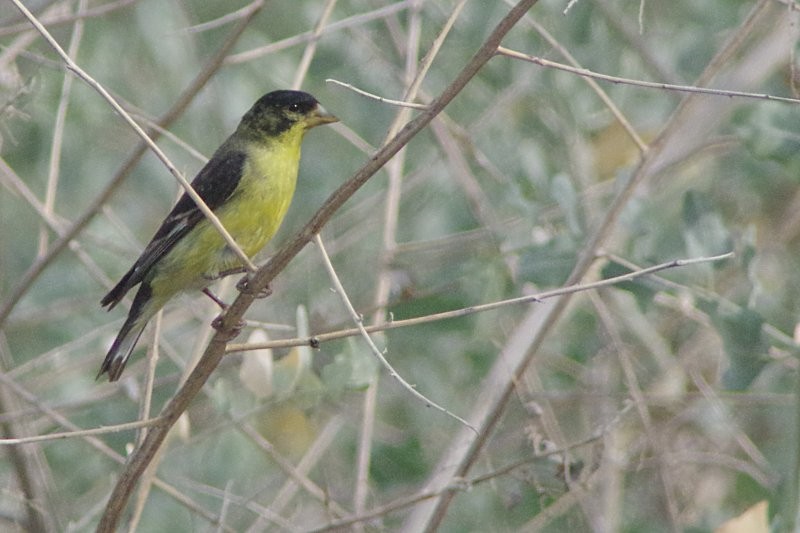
[[97, 91, 338, 381]]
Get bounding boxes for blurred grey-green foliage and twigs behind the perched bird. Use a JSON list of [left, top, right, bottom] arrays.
[[0, 0, 800, 531]]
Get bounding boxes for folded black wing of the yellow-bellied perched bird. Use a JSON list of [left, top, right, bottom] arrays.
[[100, 149, 247, 309]]
